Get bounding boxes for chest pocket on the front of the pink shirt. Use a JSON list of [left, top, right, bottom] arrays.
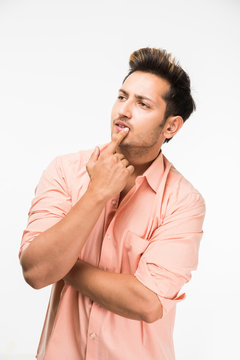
[[121, 231, 149, 274]]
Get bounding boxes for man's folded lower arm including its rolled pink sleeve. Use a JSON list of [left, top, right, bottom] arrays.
[[64, 191, 205, 322]]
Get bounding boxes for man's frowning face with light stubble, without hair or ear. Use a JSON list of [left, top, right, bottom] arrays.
[[111, 71, 170, 151]]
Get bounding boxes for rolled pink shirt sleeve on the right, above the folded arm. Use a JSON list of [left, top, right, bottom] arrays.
[[134, 192, 205, 317]]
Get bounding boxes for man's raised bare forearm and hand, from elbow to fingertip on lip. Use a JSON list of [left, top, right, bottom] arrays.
[[20, 131, 134, 289]]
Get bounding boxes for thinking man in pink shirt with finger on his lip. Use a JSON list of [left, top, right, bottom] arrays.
[[19, 48, 205, 360]]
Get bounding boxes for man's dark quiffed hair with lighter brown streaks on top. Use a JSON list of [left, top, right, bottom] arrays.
[[123, 47, 196, 142]]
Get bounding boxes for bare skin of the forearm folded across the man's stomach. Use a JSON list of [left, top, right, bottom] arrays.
[[64, 261, 162, 323]]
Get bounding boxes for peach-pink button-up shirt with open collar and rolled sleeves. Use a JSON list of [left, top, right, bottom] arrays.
[[19, 146, 205, 360]]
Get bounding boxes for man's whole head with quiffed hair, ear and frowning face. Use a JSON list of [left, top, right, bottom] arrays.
[[112, 48, 195, 160]]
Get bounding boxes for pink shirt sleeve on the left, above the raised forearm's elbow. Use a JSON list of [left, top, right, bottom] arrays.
[[19, 156, 72, 258]]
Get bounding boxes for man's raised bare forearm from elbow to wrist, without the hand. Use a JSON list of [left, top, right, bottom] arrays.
[[21, 190, 105, 288]]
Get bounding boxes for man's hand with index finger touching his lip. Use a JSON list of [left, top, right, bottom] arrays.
[[86, 131, 134, 201]]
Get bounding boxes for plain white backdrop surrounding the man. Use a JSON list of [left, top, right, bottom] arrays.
[[0, 0, 240, 360]]
